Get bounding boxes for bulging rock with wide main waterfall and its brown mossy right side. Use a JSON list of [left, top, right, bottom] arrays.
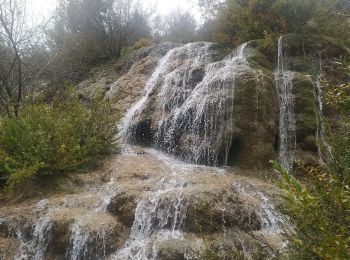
[[117, 43, 277, 167]]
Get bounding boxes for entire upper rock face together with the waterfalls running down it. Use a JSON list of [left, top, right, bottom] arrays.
[[112, 35, 349, 168]]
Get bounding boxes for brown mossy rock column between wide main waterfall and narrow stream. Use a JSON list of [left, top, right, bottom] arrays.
[[232, 67, 278, 169]]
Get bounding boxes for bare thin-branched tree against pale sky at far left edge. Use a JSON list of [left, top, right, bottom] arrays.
[[0, 0, 42, 116]]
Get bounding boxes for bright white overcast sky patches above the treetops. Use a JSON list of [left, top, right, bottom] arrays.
[[29, 0, 199, 18]]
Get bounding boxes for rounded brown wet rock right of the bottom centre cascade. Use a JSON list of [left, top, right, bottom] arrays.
[[184, 186, 261, 234]]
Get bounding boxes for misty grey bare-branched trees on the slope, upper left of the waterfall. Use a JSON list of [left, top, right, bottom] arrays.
[[48, 0, 150, 57]]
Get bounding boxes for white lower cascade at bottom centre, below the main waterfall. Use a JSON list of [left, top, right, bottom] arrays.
[[113, 177, 186, 260]]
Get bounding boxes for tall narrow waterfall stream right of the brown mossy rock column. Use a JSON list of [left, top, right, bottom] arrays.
[[275, 36, 296, 171]]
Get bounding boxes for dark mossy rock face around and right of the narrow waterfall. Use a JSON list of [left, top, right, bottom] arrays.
[[249, 34, 350, 169]]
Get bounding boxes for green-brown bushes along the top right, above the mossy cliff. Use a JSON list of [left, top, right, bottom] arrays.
[[211, 0, 350, 46]]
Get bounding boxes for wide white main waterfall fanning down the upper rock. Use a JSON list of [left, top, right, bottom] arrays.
[[122, 43, 248, 166]]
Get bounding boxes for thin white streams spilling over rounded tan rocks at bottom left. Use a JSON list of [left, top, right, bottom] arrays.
[[7, 175, 118, 260]]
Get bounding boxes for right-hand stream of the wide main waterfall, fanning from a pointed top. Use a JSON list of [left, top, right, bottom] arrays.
[[155, 45, 246, 165]]
